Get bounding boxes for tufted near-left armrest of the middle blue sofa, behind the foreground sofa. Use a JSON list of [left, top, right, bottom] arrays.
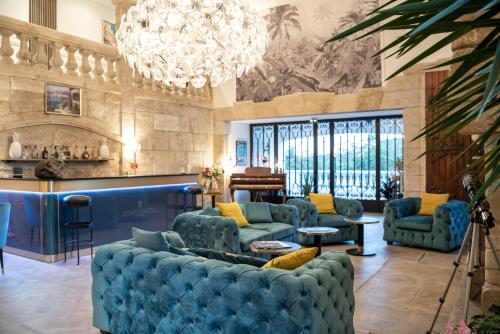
[[172, 212, 240, 253]]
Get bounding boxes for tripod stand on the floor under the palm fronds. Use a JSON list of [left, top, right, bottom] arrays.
[[427, 174, 500, 334]]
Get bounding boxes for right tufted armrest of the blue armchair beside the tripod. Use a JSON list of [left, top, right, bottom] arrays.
[[432, 201, 470, 249]]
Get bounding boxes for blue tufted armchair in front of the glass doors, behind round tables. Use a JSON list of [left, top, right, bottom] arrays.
[[286, 197, 363, 245]]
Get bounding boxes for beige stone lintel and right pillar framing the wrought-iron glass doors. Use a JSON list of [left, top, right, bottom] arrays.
[[214, 65, 428, 196]]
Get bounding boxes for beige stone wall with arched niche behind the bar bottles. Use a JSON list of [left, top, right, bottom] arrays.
[[0, 75, 121, 177]]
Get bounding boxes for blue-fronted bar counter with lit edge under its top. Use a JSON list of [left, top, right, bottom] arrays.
[[0, 174, 198, 262]]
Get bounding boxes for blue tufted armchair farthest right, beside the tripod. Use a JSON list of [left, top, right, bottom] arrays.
[[384, 197, 469, 252]]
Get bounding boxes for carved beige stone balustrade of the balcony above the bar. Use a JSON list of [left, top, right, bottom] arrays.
[[0, 15, 212, 104]]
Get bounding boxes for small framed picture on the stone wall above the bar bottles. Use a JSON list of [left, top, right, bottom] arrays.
[[45, 83, 82, 116]]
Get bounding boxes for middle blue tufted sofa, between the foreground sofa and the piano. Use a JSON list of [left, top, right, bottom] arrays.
[[172, 203, 299, 256]]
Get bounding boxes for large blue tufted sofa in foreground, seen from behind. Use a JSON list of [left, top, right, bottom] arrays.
[[92, 242, 354, 334]]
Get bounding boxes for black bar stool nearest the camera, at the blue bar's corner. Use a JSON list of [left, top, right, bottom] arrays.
[[63, 195, 94, 265]]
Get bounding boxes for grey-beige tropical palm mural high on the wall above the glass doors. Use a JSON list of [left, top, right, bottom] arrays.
[[237, 0, 381, 102]]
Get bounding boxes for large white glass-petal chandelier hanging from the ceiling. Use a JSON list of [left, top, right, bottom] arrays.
[[116, 0, 267, 88]]
